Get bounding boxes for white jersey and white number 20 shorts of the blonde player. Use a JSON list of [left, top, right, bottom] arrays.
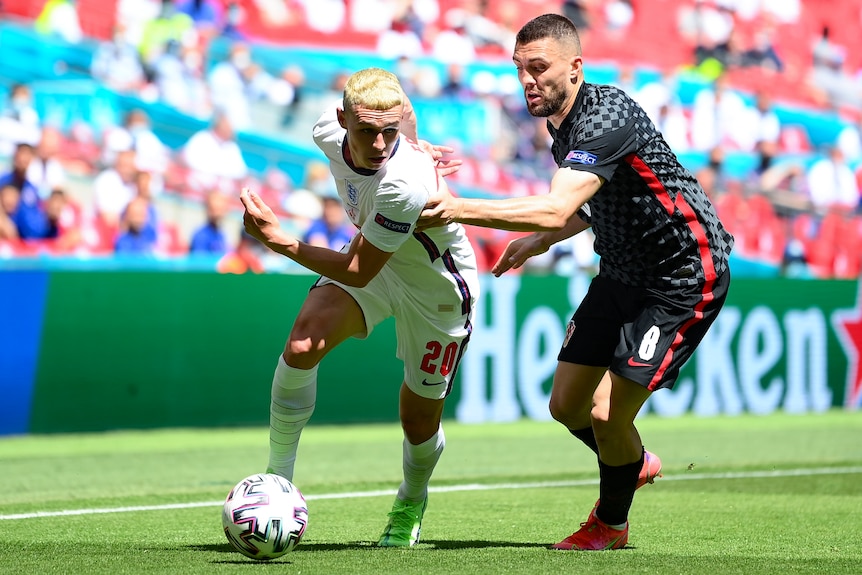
[[314, 109, 479, 399]]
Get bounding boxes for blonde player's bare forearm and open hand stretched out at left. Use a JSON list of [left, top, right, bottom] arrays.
[[240, 188, 392, 287]]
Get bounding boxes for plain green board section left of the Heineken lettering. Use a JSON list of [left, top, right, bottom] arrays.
[[30, 272, 403, 433]]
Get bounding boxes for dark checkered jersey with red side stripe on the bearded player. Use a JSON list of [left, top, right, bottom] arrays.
[[548, 83, 733, 287]]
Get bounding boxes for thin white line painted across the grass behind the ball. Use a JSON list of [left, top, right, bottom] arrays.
[[0, 467, 862, 521]]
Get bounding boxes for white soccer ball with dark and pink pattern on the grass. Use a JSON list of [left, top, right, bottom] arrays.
[[221, 473, 308, 561]]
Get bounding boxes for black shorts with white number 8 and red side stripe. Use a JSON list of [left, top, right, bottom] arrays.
[[557, 271, 730, 390]]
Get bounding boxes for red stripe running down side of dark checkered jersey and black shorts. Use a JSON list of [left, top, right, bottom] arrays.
[[626, 154, 717, 391]]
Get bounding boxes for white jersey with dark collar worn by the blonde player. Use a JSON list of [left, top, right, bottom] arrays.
[[314, 108, 476, 312]]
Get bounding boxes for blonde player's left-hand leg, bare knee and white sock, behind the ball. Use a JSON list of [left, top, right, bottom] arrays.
[[267, 284, 365, 481]]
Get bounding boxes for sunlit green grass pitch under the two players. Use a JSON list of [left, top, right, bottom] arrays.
[[0, 410, 862, 575]]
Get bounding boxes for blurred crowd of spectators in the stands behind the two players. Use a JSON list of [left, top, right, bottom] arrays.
[[0, 0, 862, 277]]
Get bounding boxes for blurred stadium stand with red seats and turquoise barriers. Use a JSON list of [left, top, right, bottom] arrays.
[[0, 0, 862, 277]]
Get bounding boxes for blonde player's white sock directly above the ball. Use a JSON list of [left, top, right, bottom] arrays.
[[267, 356, 317, 481]]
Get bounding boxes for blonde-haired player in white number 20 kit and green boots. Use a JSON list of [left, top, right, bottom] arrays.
[[240, 68, 479, 547]]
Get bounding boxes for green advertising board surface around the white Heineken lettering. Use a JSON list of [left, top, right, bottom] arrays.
[[30, 272, 858, 433]]
